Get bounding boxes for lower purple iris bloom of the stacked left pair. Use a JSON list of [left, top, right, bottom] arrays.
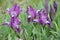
[[9, 17, 21, 33]]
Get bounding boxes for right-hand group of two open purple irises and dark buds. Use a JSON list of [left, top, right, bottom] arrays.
[[26, 1, 57, 28]]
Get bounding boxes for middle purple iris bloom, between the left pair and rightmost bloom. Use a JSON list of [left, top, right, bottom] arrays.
[[26, 6, 36, 22]]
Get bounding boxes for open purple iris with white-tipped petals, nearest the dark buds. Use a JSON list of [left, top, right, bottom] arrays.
[[37, 8, 53, 28]]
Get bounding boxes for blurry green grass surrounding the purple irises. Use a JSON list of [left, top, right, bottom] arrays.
[[0, 0, 60, 40]]
